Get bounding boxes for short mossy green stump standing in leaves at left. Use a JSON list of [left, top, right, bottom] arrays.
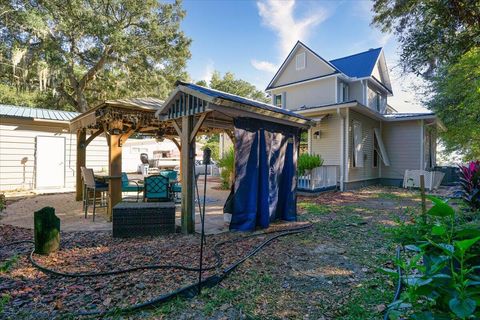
[[33, 207, 60, 254]]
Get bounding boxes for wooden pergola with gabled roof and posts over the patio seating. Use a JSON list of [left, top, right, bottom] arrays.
[[71, 82, 310, 233]]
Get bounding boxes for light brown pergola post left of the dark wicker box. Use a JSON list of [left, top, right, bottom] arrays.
[[107, 134, 122, 221]]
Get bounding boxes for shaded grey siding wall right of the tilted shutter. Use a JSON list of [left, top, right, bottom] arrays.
[[382, 120, 422, 179]]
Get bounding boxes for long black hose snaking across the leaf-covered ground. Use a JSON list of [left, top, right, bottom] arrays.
[[0, 224, 312, 316]]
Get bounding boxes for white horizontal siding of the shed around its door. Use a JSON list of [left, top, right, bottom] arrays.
[[0, 119, 108, 191]]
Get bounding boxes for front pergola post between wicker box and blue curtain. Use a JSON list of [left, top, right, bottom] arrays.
[[180, 115, 195, 234]]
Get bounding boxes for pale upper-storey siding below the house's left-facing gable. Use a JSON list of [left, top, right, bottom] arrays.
[[272, 77, 337, 110]]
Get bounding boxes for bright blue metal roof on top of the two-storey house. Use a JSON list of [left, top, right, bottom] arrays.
[[330, 48, 382, 78]]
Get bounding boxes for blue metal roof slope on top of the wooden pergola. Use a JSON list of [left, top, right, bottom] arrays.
[[177, 81, 308, 120]]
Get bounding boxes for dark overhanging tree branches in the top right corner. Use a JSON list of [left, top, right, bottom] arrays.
[[373, 0, 480, 79]]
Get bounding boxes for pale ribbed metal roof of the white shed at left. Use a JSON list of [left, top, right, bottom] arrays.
[[0, 104, 80, 121]]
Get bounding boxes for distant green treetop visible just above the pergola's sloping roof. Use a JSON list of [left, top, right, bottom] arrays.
[[208, 71, 270, 102]]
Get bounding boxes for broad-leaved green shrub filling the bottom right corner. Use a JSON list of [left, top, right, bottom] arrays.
[[383, 197, 480, 319]]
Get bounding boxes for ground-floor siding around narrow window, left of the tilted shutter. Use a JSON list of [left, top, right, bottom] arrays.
[[347, 110, 380, 182]]
